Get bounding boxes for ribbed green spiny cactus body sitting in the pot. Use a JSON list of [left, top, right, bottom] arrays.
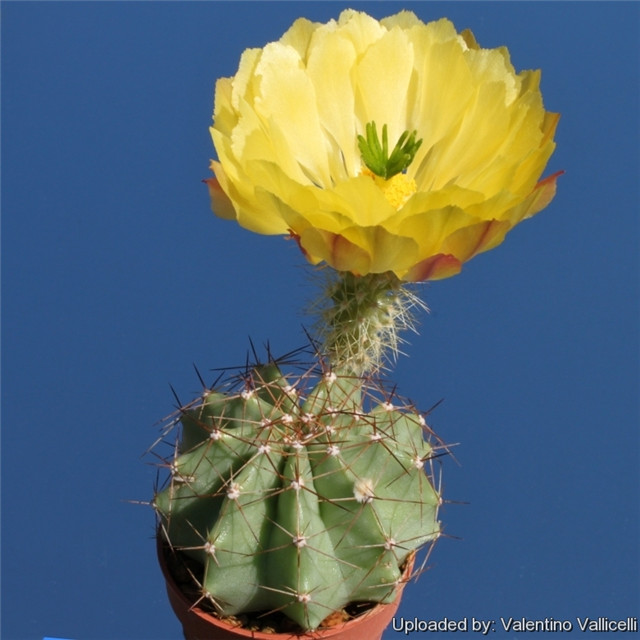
[[154, 364, 440, 629]]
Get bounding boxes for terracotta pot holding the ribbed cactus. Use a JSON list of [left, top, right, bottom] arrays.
[[157, 537, 414, 640]]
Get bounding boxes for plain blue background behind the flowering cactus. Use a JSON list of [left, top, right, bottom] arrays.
[[1, 2, 640, 640]]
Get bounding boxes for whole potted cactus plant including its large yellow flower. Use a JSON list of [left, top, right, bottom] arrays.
[[153, 10, 560, 638]]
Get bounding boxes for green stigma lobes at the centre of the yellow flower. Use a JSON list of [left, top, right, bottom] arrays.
[[358, 121, 422, 180]]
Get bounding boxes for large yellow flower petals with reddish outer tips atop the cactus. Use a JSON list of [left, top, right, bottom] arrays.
[[208, 10, 559, 281]]
